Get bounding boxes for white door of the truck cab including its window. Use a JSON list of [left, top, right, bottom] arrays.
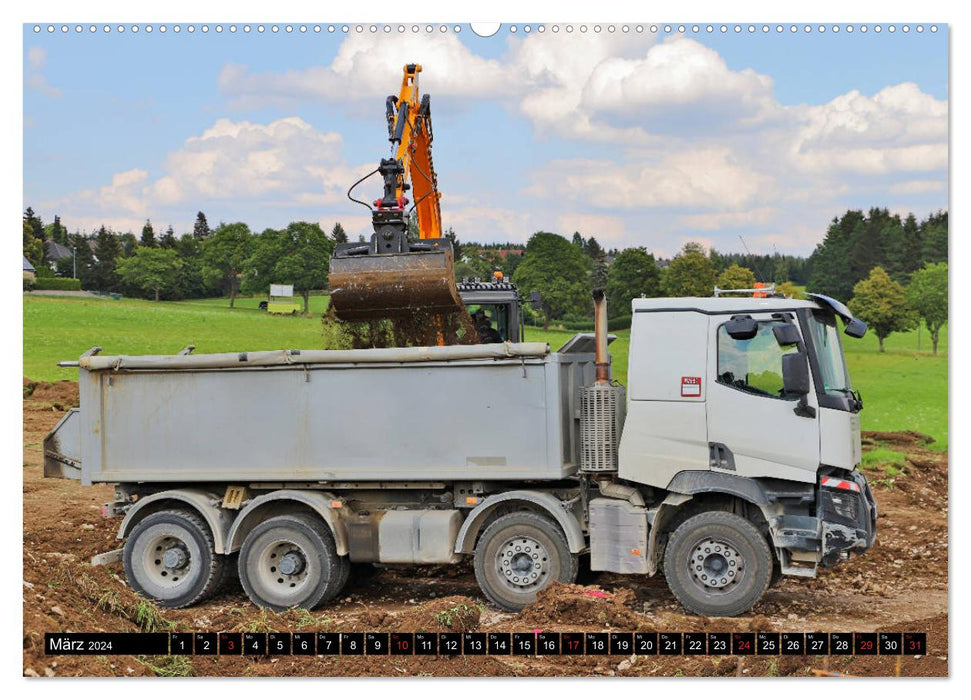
[[707, 313, 819, 482]]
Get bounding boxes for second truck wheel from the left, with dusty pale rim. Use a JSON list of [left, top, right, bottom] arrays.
[[239, 514, 350, 612]]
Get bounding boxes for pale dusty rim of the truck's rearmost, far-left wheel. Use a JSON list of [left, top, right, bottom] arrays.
[[136, 524, 202, 600]]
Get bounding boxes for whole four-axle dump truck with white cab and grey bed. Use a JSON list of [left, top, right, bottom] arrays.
[[44, 295, 876, 615]]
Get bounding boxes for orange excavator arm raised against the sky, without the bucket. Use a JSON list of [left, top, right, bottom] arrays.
[[387, 63, 442, 240]]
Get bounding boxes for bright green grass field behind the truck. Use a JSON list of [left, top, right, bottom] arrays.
[[23, 296, 948, 449]]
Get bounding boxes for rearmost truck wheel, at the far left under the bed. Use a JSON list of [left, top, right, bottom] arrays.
[[122, 510, 225, 608]]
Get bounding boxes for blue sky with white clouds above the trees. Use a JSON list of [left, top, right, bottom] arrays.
[[24, 23, 949, 256]]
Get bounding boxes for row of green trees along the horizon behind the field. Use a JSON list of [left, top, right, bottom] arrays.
[[24, 208, 948, 350]]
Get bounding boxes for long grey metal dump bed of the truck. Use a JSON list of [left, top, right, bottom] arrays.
[[44, 334, 608, 484]]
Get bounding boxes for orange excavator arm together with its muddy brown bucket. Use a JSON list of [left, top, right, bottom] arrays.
[[330, 64, 466, 321]]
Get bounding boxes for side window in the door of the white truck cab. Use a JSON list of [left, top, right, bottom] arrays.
[[718, 321, 795, 398]]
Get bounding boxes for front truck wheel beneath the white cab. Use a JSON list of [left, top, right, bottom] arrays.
[[664, 511, 772, 617]]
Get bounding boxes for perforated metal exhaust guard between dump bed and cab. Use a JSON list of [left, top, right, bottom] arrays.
[[580, 384, 624, 472]]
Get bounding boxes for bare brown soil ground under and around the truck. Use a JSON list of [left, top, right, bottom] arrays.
[[23, 379, 948, 676]]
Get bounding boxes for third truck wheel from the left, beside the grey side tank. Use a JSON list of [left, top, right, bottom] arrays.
[[475, 511, 577, 612]]
